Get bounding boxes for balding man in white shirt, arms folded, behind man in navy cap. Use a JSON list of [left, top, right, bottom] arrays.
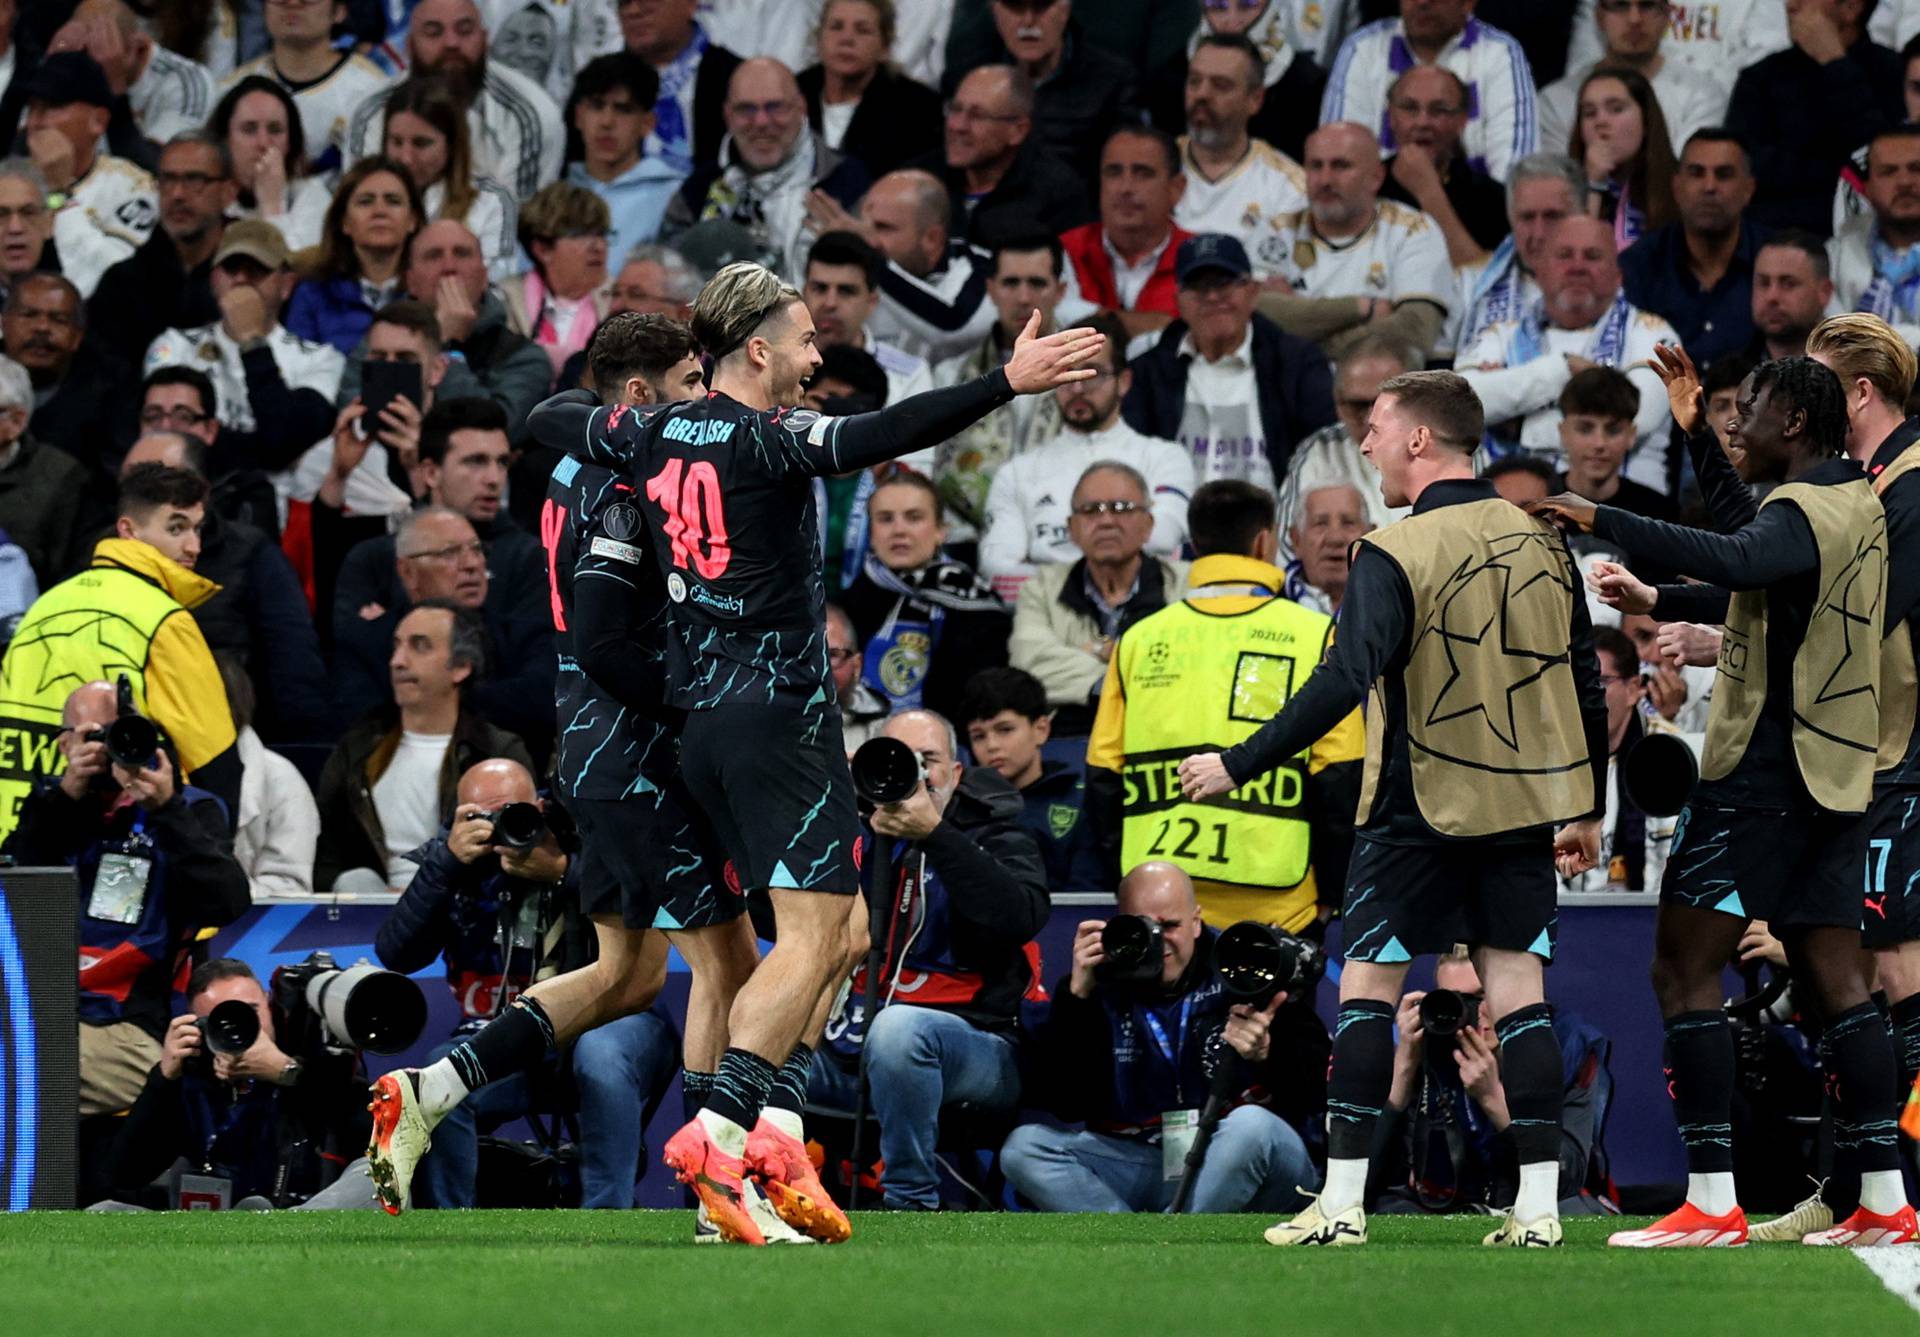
[[1256, 123, 1453, 359]]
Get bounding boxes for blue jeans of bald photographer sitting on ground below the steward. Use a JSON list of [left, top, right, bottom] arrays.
[[1000, 1105, 1319, 1212]]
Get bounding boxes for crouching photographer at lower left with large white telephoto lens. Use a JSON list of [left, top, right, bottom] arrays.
[[90, 953, 426, 1212]]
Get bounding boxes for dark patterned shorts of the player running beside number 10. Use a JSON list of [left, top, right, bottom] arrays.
[[568, 780, 747, 930]]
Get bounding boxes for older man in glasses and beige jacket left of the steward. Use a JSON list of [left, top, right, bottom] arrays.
[[1008, 463, 1187, 736]]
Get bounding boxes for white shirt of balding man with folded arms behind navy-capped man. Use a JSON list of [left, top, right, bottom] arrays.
[[1252, 200, 1455, 311]]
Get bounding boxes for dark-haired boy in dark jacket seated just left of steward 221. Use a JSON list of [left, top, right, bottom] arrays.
[[962, 669, 1108, 893]]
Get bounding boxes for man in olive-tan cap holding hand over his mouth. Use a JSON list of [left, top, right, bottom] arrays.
[[144, 219, 344, 474]]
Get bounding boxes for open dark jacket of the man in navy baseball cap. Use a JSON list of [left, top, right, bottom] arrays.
[[1119, 313, 1334, 478]]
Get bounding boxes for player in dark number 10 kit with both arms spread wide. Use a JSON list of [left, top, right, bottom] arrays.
[[530, 263, 1104, 1243]]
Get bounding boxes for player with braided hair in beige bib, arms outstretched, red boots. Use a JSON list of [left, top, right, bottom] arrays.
[[1534, 348, 1914, 1249]]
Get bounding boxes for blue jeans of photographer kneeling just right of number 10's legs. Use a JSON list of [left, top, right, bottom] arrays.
[[806, 1003, 1020, 1206]]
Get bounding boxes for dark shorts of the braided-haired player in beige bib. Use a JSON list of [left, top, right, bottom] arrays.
[[1661, 803, 1862, 936]]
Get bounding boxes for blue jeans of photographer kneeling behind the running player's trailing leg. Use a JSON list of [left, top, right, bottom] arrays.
[[413, 1010, 680, 1206]]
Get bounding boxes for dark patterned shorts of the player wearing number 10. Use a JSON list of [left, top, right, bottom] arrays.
[[680, 699, 860, 895]]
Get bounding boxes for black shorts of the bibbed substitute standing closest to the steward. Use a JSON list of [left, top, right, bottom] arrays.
[[1340, 836, 1559, 966]]
